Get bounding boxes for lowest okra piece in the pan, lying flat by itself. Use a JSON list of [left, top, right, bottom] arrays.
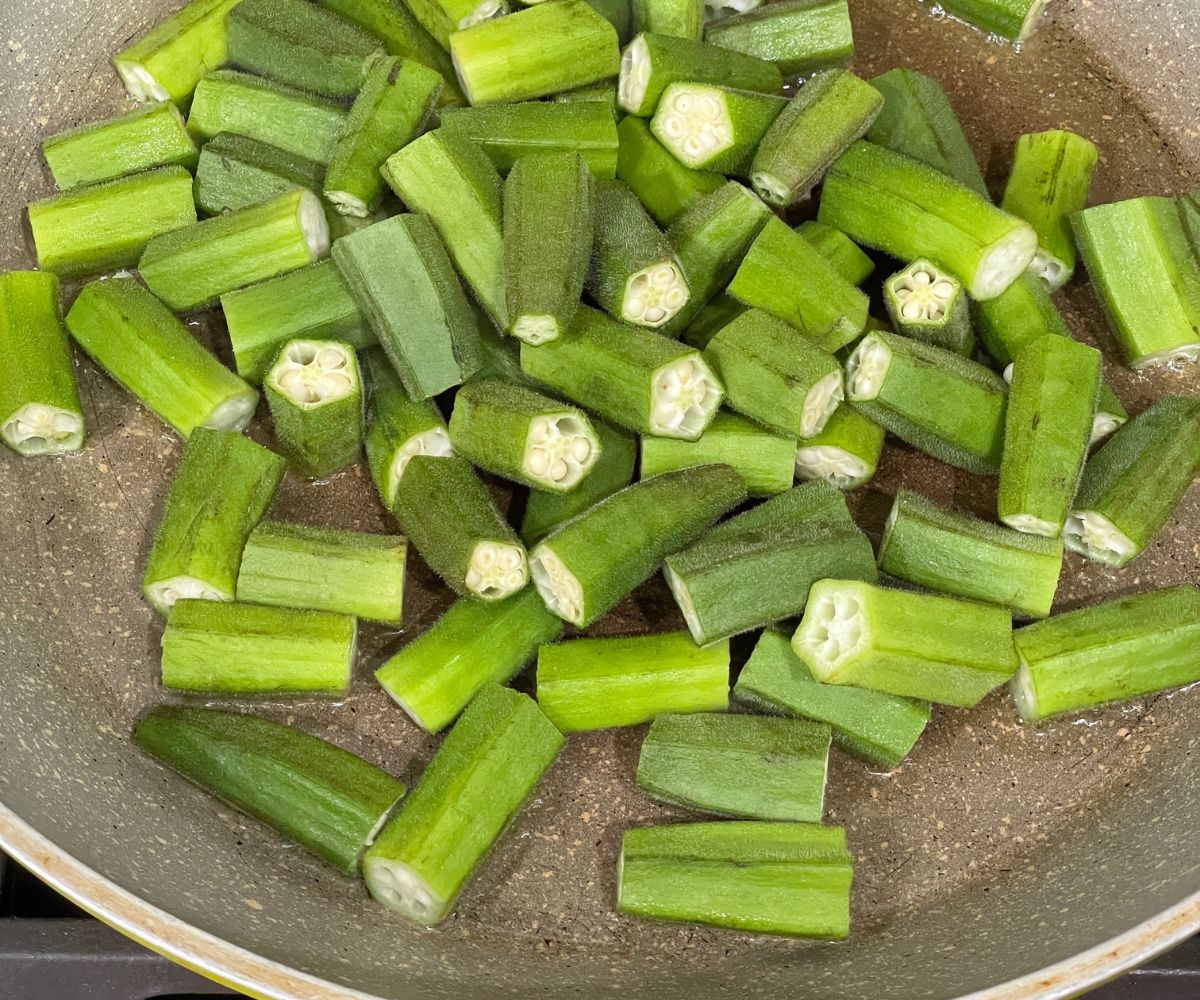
[[617, 820, 854, 940]]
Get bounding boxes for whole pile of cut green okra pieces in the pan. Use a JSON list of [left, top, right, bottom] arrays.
[[0, 0, 1200, 939]]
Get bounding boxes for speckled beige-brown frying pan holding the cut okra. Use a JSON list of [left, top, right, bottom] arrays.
[[0, 0, 1200, 1000]]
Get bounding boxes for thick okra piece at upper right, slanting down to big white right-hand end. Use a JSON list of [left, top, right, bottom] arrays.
[[818, 142, 1038, 300]]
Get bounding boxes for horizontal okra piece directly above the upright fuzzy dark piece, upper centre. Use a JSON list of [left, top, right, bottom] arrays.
[[442, 101, 618, 180]]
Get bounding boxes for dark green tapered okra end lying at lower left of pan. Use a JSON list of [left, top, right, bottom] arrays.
[[133, 706, 404, 875]]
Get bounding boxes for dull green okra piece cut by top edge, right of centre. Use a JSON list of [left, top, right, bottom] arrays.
[[704, 0, 854, 77]]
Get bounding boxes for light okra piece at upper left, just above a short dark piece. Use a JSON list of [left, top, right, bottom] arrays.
[[187, 70, 346, 166]]
